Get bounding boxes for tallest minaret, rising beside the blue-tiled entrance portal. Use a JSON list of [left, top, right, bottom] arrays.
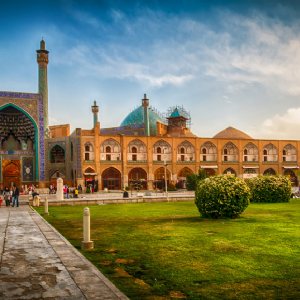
[[36, 39, 49, 135]]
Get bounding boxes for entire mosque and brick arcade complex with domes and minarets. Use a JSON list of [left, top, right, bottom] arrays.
[[0, 40, 300, 190]]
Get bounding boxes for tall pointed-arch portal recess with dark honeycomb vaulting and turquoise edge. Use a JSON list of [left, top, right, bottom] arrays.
[[0, 104, 39, 187]]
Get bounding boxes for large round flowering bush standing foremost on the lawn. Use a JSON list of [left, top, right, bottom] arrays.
[[195, 175, 250, 219]]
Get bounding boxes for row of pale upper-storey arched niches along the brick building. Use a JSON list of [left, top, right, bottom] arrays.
[[50, 139, 297, 163]]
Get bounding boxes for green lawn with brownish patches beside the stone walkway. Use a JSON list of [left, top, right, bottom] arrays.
[[35, 199, 300, 299]]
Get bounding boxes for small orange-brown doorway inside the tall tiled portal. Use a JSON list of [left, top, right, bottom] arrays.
[[3, 160, 21, 187]]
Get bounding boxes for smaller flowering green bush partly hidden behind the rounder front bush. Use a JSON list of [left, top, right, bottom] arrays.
[[247, 175, 291, 203]]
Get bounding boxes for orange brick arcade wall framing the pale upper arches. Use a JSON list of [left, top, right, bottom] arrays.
[[72, 128, 300, 189]]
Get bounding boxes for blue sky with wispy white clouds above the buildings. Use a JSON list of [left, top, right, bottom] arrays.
[[0, 0, 300, 140]]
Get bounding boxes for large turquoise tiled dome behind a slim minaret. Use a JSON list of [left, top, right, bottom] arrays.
[[120, 106, 165, 135]]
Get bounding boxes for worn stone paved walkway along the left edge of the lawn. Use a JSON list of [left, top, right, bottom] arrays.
[[0, 205, 128, 300]]
